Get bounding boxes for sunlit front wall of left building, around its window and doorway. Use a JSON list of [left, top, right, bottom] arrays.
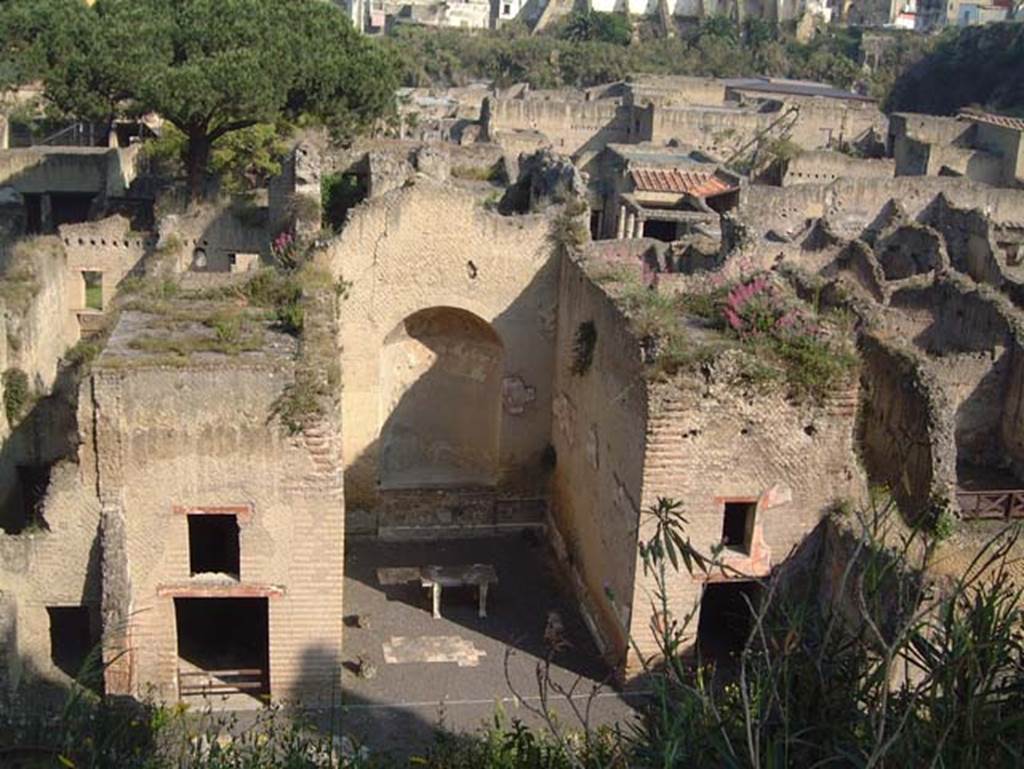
[[89, 339, 344, 701]]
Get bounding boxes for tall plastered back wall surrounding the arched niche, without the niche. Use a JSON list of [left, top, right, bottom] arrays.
[[318, 178, 557, 530]]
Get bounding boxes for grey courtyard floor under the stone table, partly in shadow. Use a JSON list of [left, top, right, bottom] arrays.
[[333, 535, 641, 754]]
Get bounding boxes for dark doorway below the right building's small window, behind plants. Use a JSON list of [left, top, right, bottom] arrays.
[[697, 581, 760, 661]]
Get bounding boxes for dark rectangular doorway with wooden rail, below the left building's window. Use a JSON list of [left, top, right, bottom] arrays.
[[174, 597, 270, 697]]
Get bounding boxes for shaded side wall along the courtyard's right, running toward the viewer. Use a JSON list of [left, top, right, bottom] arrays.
[[552, 259, 647, 663]]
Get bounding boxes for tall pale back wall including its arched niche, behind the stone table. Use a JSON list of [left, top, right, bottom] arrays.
[[318, 178, 558, 531]]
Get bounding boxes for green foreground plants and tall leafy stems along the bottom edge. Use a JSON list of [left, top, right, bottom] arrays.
[[0, 499, 1024, 769]]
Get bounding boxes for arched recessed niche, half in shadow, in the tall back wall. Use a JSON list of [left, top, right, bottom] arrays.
[[379, 307, 504, 488]]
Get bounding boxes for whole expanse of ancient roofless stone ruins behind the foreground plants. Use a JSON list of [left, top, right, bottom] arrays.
[[0, 73, 1024, 700]]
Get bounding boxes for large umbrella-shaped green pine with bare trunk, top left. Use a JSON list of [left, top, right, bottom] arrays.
[[0, 0, 397, 197]]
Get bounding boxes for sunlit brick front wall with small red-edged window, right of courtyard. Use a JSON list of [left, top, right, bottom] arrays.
[[630, 370, 864, 670]]
